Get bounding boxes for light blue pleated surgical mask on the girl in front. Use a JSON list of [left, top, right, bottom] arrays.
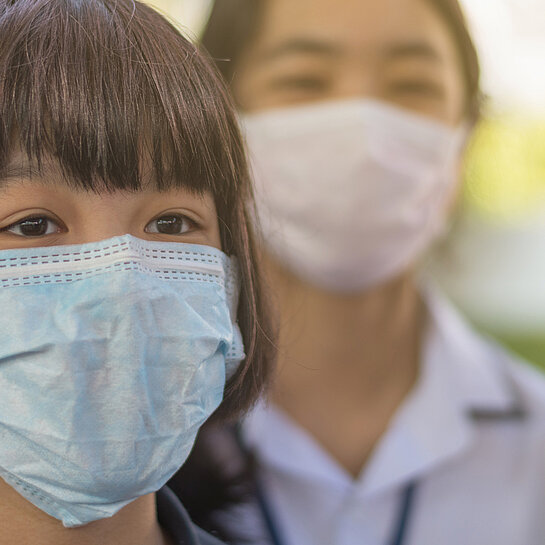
[[0, 235, 244, 527]]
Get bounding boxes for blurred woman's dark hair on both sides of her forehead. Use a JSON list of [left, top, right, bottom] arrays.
[[201, 0, 482, 120]]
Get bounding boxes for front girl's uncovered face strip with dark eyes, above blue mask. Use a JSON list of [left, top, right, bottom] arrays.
[[0, 151, 221, 250]]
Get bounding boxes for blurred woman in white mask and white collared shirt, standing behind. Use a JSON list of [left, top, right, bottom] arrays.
[[172, 0, 545, 545]]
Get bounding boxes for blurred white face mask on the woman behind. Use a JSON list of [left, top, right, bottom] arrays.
[[242, 100, 466, 292]]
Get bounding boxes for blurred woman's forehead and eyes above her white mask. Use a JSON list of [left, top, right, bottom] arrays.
[[233, 0, 465, 126]]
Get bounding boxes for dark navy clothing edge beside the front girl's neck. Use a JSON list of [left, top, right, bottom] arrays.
[[156, 486, 223, 545]]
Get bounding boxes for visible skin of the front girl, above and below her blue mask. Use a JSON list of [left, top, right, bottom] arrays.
[[0, 154, 221, 545]]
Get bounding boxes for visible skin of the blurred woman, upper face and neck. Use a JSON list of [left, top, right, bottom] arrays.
[[233, 0, 465, 477]]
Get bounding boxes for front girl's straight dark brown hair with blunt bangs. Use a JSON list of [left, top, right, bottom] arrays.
[[0, 0, 272, 418]]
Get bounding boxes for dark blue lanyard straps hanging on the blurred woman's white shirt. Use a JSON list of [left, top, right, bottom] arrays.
[[255, 472, 417, 545]]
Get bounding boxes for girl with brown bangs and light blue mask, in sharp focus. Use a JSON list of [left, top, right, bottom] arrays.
[[0, 0, 271, 545]]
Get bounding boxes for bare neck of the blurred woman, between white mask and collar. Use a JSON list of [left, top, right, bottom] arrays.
[[268, 255, 425, 476]]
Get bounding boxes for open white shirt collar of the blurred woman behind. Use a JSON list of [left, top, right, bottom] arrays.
[[244, 288, 520, 497]]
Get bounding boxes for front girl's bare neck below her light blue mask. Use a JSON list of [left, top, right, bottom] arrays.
[[0, 479, 170, 545]]
